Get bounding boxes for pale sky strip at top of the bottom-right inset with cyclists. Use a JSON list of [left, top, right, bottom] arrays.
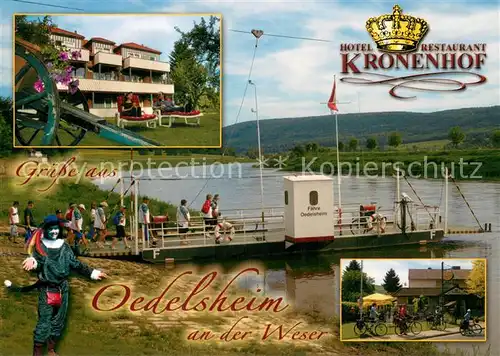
[[342, 259, 472, 286]]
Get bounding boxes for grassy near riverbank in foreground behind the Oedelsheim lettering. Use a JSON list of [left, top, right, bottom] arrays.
[[0, 250, 476, 356]]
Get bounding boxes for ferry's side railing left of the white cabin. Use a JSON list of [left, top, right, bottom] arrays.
[[142, 215, 284, 250]]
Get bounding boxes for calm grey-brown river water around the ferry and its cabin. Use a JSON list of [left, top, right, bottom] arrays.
[[96, 164, 500, 356]]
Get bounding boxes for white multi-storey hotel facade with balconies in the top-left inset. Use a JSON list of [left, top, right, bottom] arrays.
[[50, 28, 174, 117]]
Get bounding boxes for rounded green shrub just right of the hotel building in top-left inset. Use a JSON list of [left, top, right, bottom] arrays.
[[172, 56, 207, 110]]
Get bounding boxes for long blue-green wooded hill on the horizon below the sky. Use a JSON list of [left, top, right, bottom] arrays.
[[223, 106, 500, 153]]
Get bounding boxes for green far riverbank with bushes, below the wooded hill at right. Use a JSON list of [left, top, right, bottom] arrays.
[[266, 149, 500, 181]]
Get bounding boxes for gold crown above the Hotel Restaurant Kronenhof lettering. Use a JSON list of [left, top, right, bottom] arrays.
[[366, 5, 429, 52]]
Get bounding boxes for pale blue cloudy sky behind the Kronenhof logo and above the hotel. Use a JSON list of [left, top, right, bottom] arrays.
[[0, 0, 500, 126]]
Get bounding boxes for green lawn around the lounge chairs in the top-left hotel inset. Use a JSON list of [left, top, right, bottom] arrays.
[[15, 113, 222, 148]]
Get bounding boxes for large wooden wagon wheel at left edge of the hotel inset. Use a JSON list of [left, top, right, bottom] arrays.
[[14, 40, 61, 146]]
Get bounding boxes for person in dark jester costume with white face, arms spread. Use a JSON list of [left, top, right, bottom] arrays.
[[4, 215, 107, 356]]
